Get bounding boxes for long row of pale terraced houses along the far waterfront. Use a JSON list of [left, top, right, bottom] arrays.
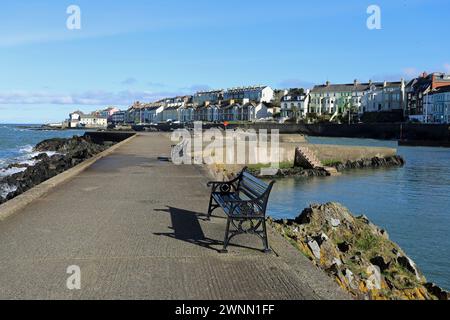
[[64, 73, 450, 128]]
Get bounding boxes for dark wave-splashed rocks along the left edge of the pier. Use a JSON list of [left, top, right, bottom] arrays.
[[0, 136, 114, 204]]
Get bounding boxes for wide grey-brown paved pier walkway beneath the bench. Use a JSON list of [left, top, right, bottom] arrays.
[[0, 134, 346, 299]]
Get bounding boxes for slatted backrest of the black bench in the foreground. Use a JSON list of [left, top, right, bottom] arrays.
[[237, 170, 275, 212]]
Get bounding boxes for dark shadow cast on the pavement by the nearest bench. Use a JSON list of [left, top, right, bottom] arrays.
[[154, 207, 255, 252]]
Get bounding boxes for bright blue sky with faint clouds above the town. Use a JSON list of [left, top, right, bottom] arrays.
[[0, 0, 450, 123]]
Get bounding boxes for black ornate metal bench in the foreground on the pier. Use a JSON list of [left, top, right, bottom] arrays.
[[208, 168, 275, 253]]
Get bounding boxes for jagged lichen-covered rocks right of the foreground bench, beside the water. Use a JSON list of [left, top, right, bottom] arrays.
[[270, 203, 450, 300]]
